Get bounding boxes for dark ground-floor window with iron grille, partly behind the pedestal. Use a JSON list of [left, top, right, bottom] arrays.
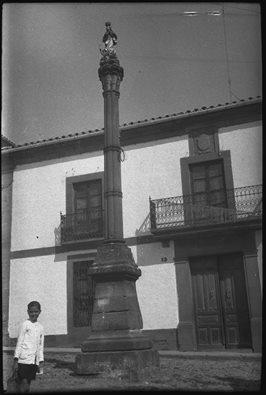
[[73, 261, 94, 327]]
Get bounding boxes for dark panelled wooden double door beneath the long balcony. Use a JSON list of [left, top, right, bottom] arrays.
[[190, 254, 251, 349]]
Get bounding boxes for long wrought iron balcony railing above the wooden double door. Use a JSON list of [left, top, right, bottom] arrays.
[[150, 185, 262, 231]]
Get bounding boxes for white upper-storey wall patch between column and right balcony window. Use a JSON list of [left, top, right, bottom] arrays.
[[121, 136, 189, 237]]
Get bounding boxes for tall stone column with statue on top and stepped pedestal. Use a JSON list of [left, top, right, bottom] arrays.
[[76, 22, 159, 374]]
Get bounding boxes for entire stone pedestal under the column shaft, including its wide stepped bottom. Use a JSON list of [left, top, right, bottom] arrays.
[[76, 242, 159, 374]]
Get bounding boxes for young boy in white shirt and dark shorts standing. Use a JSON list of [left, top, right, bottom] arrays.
[[13, 301, 44, 392]]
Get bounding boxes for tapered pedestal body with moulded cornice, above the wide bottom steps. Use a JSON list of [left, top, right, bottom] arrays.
[[89, 243, 142, 332]]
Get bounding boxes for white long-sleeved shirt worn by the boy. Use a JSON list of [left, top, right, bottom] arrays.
[[14, 320, 44, 365]]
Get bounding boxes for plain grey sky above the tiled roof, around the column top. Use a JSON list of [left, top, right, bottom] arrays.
[[1, 2, 262, 144]]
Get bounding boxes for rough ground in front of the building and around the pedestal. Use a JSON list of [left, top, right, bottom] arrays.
[[3, 353, 261, 393]]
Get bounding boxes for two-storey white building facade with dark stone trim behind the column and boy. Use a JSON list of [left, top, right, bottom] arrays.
[[2, 98, 262, 352]]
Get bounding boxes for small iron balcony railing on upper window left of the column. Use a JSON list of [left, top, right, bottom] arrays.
[[60, 209, 103, 243]]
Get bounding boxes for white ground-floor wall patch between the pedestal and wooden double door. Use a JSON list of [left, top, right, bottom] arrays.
[[131, 242, 178, 329]]
